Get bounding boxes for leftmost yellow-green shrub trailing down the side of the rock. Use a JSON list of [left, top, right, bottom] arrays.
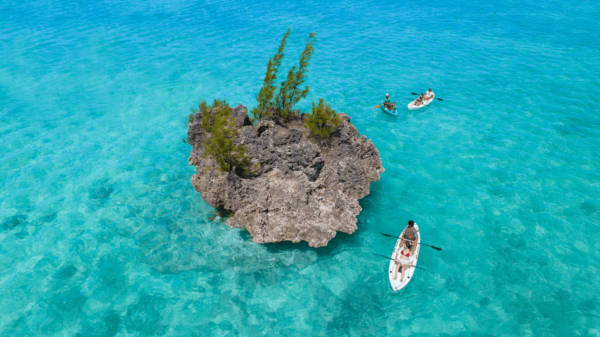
[[199, 99, 250, 173]]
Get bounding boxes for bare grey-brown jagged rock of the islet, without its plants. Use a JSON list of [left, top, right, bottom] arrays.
[[188, 105, 384, 247]]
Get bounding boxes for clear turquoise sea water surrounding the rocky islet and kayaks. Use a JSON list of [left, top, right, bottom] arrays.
[[0, 0, 600, 336]]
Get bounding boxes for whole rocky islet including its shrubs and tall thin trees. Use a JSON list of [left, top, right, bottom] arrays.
[[187, 31, 384, 247]]
